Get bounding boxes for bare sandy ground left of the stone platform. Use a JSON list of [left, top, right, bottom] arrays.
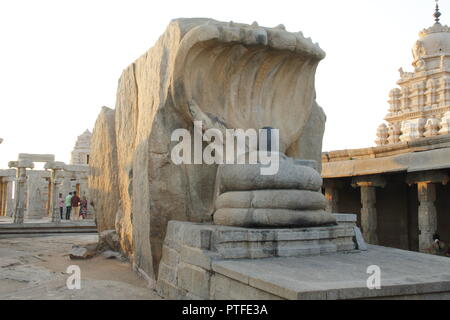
[[0, 235, 161, 300]]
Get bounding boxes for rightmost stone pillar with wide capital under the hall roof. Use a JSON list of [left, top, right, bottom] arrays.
[[406, 170, 449, 252]]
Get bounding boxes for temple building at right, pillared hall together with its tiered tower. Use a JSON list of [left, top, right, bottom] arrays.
[[322, 1, 450, 253]]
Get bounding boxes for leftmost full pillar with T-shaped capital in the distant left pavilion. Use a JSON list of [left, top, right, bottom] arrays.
[[8, 160, 34, 224]]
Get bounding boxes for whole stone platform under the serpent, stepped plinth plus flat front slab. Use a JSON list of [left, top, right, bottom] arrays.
[[157, 215, 450, 300]]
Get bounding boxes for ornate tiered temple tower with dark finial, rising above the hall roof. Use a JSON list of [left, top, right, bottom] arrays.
[[375, 4, 450, 146]]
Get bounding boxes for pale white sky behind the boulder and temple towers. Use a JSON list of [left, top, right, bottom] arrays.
[[0, 0, 442, 168]]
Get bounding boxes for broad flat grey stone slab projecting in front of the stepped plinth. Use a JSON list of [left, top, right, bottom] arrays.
[[212, 245, 450, 300]]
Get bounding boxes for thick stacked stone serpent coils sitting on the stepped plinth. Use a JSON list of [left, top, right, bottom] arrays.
[[214, 151, 336, 228]]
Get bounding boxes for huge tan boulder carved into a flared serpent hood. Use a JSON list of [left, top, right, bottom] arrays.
[[91, 19, 325, 278]]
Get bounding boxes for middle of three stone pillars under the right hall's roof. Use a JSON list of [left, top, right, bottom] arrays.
[[352, 175, 386, 244]]
